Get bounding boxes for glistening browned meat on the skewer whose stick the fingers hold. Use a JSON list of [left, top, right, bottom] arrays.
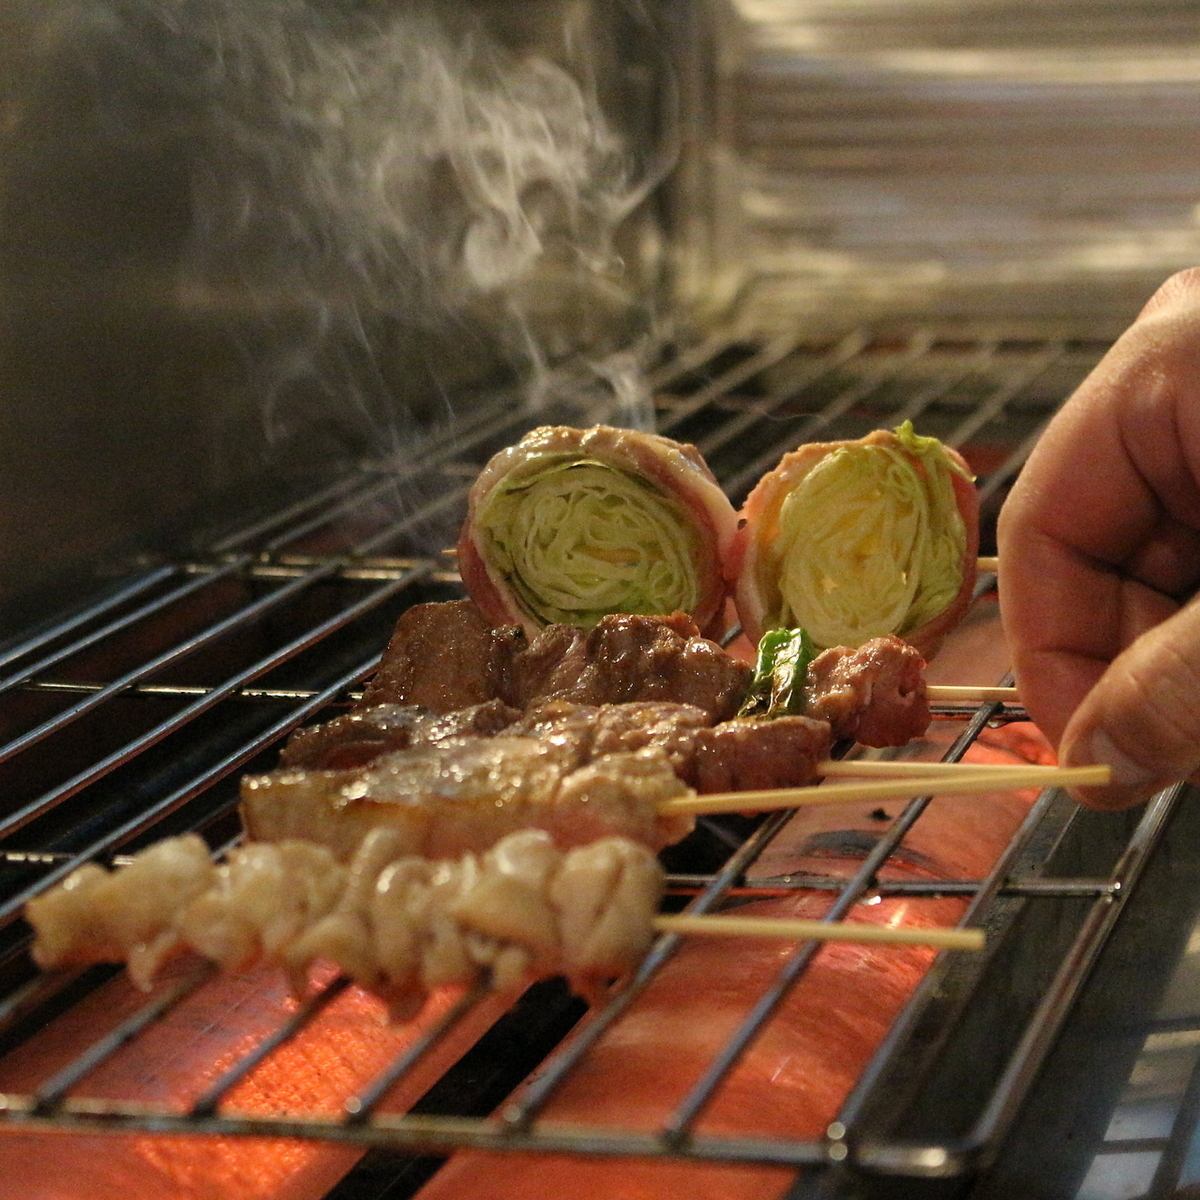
[[241, 734, 692, 858]]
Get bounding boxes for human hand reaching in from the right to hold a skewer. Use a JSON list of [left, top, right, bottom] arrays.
[[998, 269, 1200, 808]]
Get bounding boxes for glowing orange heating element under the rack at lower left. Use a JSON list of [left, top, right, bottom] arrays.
[[0, 968, 506, 1200]]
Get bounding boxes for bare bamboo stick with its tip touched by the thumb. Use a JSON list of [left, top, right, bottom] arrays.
[[658, 764, 1111, 815]]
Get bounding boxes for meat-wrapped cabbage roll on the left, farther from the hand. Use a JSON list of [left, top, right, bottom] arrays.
[[458, 425, 737, 635]]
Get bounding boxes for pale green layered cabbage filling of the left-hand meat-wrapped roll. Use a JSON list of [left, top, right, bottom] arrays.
[[476, 457, 701, 629]]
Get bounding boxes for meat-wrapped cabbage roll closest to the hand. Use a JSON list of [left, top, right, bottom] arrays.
[[730, 421, 979, 658]]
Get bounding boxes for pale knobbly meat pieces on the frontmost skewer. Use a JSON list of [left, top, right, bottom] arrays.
[[25, 829, 662, 1014]]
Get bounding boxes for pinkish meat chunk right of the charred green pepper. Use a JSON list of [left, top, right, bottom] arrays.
[[804, 637, 930, 746]]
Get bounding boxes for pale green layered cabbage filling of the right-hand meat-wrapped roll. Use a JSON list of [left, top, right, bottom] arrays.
[[766, 421, 968, 647]]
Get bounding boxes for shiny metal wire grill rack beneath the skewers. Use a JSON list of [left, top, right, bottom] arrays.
[[0, 329, 1178, 1177]]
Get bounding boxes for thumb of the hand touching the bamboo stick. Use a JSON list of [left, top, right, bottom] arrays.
[[1060, 600, 1200, 809]]
